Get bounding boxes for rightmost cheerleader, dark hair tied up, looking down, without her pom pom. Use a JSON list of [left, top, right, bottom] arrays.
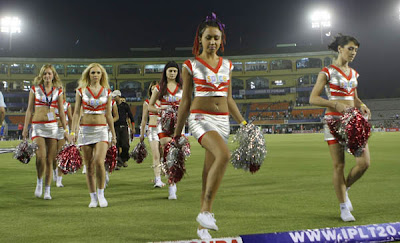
[[310, 35, 371, 221]]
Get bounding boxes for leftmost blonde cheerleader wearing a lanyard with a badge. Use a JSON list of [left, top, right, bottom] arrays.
[[22, 64, 70, 200]]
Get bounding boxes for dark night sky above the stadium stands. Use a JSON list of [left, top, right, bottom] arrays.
[[0, 0, 400, 98]]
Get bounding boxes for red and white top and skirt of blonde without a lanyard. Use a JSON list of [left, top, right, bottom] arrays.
[[77, 87, 111, 146]]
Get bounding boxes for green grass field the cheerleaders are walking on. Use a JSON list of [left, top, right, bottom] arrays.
[[0, 133, 400, 242]]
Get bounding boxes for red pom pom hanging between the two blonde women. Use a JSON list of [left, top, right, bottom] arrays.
[[56, 144, 82, 174]]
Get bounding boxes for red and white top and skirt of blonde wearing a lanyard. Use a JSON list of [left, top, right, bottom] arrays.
[[30, 85, 63, 140]]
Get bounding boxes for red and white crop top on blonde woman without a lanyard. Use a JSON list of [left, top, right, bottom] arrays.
[[78, 87, 111, 114]]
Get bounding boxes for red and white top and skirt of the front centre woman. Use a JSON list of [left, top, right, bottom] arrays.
[[183, 57, 233, 143]]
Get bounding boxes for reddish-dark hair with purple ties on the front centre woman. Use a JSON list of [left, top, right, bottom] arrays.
[[192, 13, 226, 56]]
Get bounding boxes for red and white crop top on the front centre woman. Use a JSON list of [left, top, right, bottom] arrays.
[[183, 57, 233, 97]]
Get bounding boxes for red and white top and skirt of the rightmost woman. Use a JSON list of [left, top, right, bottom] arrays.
[[320, 65, 360, 144]]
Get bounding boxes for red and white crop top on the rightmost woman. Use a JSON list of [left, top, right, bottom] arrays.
[[320, 65, 360, 100]]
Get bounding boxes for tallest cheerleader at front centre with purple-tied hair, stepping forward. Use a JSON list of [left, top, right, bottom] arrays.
[[175, 13, 247, 239]]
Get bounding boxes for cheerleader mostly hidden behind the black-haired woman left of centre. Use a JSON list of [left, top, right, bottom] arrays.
[[140, 81, 165, 187]]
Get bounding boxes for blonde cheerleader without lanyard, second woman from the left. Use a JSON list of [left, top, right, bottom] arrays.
[[72, 63, 116, 208]]
